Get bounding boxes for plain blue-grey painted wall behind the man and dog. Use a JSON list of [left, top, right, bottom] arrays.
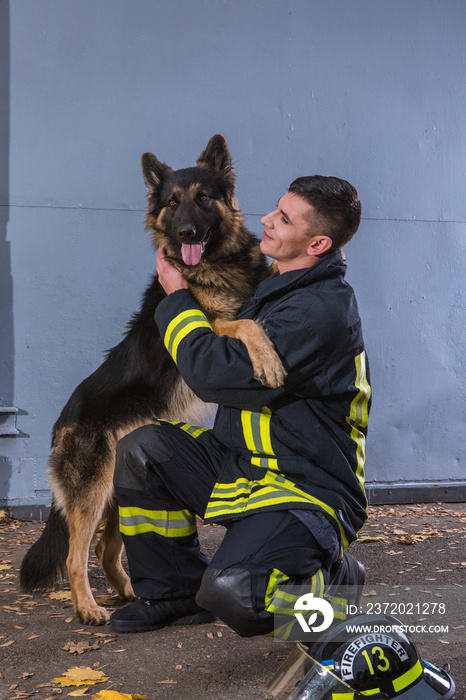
[[0, 0, 466, 507]]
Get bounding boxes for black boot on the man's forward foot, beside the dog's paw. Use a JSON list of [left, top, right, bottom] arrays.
[[110, 596, 215, 632]]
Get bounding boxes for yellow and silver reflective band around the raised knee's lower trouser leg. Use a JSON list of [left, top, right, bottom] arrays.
[[118, 507, 196, 537]]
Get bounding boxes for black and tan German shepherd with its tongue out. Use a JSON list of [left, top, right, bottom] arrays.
[[20, 134, 285, 625]]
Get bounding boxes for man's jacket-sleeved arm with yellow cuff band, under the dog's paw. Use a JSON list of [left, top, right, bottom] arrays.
[[155, 289, 320, 410]]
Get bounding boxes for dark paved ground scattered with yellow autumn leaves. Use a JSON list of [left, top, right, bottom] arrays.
[[0, 504, 466, 700]]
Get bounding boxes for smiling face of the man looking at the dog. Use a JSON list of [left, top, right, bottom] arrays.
[[260, 192, 315, 272]]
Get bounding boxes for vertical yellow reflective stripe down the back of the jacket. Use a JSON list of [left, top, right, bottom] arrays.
[[346, 351, 371, 490]]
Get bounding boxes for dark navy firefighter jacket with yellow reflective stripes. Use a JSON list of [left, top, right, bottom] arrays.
[[155, 251, 371, 548]]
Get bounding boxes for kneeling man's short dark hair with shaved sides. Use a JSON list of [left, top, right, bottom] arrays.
[[288, 175, 361, 250]]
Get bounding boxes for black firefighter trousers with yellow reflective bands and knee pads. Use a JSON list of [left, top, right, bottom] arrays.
[[114, 421, 354, 638]]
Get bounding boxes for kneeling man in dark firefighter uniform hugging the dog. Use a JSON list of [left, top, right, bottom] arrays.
[[111, 176, 371, 636]]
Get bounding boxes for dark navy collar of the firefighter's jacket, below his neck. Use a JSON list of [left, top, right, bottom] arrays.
[[251, 250, 346, 302]]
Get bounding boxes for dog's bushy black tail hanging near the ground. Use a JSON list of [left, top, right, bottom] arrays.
[[19, 503, 69, 593]]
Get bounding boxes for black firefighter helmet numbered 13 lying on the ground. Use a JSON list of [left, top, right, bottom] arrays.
[[269, 615, 455, 700]]
